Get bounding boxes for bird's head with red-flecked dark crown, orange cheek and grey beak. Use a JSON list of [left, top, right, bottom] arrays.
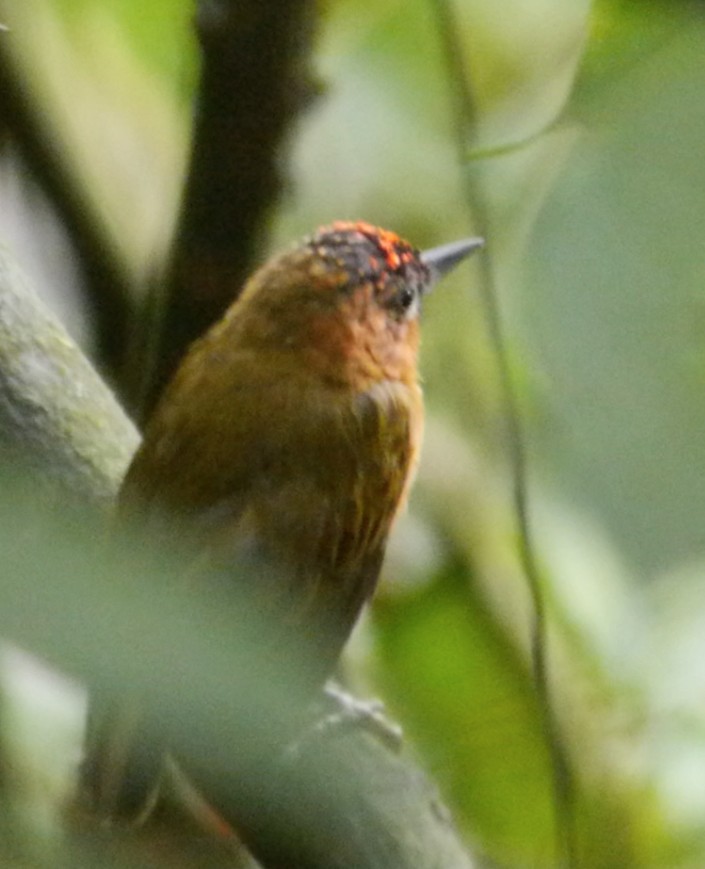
[[227, 221, 482, 388]]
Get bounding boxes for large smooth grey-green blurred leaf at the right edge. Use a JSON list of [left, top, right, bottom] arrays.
[[518, 22, 705, 576]]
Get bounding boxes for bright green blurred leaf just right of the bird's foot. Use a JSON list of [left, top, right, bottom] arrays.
[[376, 568, 553, 865]]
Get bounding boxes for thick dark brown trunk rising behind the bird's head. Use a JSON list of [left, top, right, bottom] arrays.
[[143, 0, 316, 407]]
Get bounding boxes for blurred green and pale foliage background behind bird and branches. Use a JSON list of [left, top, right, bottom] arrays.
[[0, 0, 705, 867]]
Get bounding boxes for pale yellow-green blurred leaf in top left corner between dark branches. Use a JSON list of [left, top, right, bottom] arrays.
[[0, 0, 194, 278]]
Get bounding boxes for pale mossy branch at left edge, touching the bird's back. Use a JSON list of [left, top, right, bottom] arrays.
[[0, 247, 139, 502]]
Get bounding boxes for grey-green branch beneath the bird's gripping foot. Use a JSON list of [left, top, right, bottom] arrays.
[[207, 728, 473, 869]]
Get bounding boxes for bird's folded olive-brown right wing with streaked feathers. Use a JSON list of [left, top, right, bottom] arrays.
[[234, 382, 422, 659]]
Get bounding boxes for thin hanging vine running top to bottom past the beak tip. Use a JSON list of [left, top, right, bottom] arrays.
[[426, 0, 577, 867]]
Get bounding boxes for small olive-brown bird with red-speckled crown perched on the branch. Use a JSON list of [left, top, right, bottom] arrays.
[[83, 222, 482, 817]]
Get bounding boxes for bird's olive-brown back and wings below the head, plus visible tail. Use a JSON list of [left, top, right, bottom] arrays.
[[84, 360, 417, 817]]
